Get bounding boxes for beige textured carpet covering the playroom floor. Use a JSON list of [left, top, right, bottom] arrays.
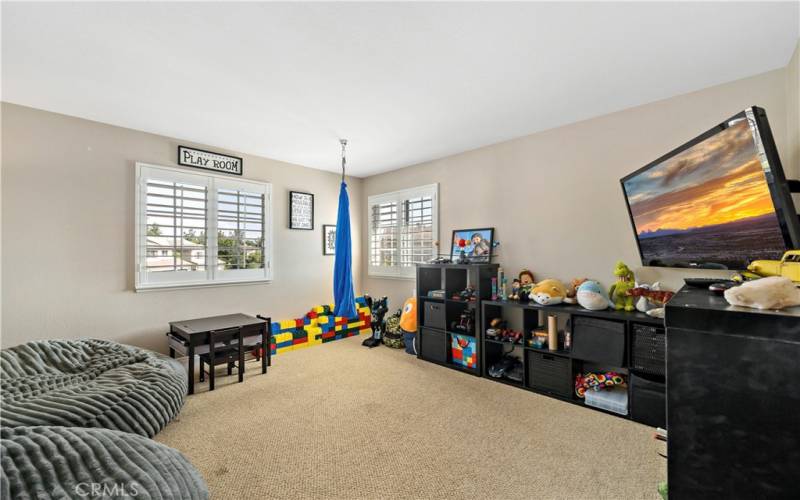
[[156, 338, 666, 499]]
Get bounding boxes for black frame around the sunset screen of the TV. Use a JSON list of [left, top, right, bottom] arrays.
[[619, 106, 800, 270]]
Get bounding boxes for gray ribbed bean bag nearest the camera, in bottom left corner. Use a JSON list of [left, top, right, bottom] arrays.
[[0, 427, 208, 500]]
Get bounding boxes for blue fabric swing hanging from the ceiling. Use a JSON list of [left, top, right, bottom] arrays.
[[333, 181, 356, 318]]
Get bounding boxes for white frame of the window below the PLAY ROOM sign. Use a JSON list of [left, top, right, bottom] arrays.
[[133, 162, 275, 292]]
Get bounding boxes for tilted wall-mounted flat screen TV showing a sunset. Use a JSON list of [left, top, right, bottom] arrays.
[[621, 107, 800, 270]]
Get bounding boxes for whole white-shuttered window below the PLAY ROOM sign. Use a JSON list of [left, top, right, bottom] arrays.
[[135, 163, 272, 290]]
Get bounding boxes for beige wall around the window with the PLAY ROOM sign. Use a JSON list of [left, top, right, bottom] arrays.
[[2, 103, 363, 351]]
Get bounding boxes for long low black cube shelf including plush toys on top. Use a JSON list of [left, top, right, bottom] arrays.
[[479, 263, 671, 427]]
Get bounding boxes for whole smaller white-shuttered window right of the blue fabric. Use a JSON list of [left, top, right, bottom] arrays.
[[367, 184, 438, 278]]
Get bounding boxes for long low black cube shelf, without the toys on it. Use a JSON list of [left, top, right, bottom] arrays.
[[478, 300, 666, 427]]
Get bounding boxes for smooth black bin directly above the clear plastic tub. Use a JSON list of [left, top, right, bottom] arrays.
[[572, 315, 625, 368]]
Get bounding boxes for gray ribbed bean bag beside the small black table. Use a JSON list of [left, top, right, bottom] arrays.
[[0, 339, 186, 437]]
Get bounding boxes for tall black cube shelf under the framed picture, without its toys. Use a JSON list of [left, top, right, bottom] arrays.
[[417, 264, 499, 376]]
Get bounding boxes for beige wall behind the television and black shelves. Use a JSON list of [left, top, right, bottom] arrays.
[[362, 69, 799, 308]]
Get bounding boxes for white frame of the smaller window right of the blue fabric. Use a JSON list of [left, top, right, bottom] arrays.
[[366, 183, 440, 279]]
